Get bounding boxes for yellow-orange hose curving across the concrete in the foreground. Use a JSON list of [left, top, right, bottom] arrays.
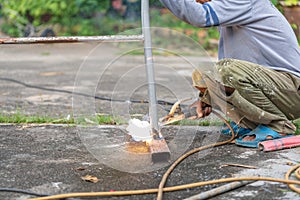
[[31, 111, 300, 200]]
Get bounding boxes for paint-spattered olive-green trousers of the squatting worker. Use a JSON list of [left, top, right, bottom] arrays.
[[203, 59, 300, 134]]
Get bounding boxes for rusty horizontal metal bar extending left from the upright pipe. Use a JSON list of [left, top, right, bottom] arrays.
[[0, 35, 144, 44]]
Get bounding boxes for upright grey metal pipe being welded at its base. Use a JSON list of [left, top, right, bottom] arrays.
[[141, 0, 159, 134]]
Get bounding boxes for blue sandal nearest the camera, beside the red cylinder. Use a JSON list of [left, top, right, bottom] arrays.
[[235, 125, 291, 148]]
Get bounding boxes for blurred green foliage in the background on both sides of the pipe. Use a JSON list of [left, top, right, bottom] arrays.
[[0, 0, 298, 48]]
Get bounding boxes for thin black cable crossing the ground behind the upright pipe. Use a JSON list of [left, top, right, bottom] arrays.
[[0, 77, 174, 106]]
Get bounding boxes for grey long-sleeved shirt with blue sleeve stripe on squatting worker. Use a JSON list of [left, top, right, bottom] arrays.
[[160, 0, 300, 77]]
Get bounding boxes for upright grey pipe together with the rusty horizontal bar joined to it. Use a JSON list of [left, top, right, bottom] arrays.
[[0, 0, 159, 133]]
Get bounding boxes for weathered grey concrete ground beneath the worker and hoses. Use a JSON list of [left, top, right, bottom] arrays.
[[0, 39, 300, 200]]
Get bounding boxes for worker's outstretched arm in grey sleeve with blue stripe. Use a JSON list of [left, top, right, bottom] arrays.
[[160, 0, 253, 27]]
